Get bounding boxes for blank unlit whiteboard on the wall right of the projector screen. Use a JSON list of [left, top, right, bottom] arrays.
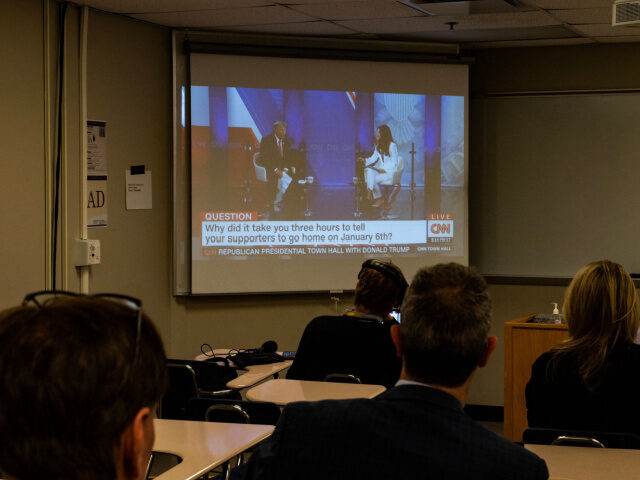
[[469, 93, 640, 277]]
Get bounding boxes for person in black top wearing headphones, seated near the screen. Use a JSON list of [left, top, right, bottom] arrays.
[[286, 260, 407, 388]]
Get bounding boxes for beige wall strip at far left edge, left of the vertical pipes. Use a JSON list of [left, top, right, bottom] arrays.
[[0, 0, 45, 307]]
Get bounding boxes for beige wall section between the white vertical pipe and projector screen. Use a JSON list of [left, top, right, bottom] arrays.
[[87, 10, 175, 344]]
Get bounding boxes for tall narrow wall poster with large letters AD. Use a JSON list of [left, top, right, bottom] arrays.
[[87, 120, 108, 227]]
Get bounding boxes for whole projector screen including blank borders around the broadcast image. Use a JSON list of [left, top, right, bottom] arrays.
[[175, 33, 468, 294]]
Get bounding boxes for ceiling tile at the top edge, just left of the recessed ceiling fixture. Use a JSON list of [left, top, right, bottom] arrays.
[[291, 0, 424, 20]]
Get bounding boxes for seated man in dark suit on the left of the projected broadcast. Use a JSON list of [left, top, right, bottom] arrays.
[[258, 121, 300, 216]]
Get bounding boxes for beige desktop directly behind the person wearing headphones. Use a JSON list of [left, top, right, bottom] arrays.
[[247, 379, 386, 406]]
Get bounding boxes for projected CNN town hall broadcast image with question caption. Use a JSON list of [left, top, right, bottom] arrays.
[[190, 86, 466, 261]]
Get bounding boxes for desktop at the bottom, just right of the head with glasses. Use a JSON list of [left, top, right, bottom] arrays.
[[153, 419, 274, 480]]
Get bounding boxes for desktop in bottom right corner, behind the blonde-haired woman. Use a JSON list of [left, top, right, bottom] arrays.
[[525, 445, 640, 480]]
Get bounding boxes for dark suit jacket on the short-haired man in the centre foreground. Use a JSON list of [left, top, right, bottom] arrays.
[[242, 387, 548, 480]]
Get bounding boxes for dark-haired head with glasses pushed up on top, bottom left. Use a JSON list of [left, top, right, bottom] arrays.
[[0, 297, 167, 480]]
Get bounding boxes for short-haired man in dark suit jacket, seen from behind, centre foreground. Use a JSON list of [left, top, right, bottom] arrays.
[[246, 263, 548, 480]]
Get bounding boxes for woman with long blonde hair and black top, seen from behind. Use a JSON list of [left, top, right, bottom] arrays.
[[525, 260, 640, 433]]
